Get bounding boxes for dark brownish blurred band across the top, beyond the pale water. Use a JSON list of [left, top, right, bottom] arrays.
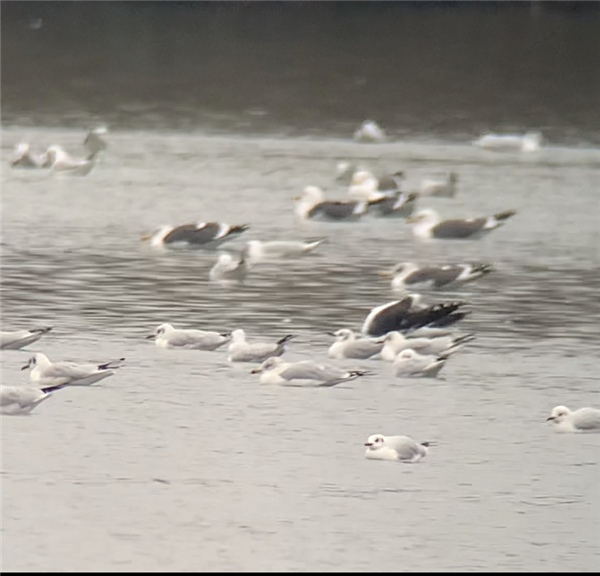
[[0, 0, 600, 145]]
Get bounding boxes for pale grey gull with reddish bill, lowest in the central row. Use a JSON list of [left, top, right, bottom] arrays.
[[251, 357, 368, 387]]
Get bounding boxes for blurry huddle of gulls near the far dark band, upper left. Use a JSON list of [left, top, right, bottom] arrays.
[[11, 126, 107, 176]]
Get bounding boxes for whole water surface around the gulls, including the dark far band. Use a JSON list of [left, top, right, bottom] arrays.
[[0, 1, 600, 572]]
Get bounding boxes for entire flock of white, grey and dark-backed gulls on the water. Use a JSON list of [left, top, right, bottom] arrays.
[[0, 120, 600, 462]]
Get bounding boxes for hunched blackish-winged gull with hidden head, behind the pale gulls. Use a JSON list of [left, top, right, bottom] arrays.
[[361, 294, 468, 337]]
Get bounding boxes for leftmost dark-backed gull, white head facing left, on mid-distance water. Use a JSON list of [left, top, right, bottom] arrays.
[[142, 222, 250, 248]]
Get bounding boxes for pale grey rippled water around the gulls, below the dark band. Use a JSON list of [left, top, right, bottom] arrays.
[[0, 127, 600, 571]]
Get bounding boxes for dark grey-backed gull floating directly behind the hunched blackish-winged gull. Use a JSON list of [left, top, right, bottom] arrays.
[[379, 262, 494, 291]]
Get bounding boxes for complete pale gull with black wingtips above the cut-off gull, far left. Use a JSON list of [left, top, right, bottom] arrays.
[[21, 352, 125, 387]]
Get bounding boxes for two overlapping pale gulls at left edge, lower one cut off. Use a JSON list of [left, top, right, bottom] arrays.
[[0, 352, 125, 415]]
